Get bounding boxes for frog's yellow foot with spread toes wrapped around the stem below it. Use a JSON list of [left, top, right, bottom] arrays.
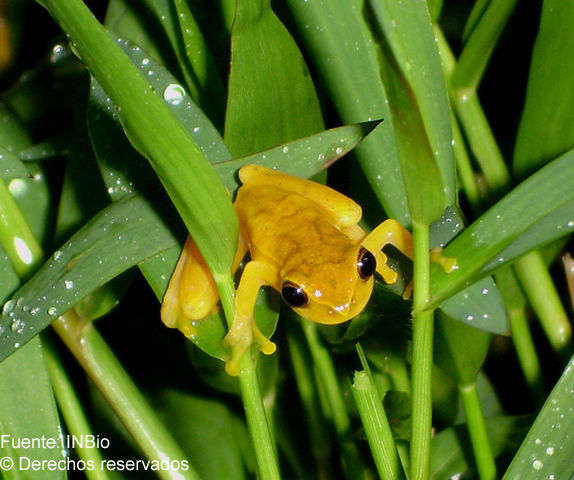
[[223, 317, 277, 377]]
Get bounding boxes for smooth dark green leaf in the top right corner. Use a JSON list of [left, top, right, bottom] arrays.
[[513, 0, 574, 178]]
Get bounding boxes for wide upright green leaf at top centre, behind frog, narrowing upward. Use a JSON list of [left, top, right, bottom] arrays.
[[224, 0, 323, 157]]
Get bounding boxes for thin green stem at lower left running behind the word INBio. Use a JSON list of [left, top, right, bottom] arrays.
[[42, 342, 109, 480]]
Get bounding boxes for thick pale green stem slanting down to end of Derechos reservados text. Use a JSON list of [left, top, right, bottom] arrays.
[[52, 310, 200, 480]]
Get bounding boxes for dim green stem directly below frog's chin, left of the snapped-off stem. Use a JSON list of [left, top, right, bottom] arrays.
[[302, 320, 366, 479]]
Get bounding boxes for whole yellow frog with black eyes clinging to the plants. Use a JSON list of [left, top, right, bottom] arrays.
[[161, 165, 446, 375]]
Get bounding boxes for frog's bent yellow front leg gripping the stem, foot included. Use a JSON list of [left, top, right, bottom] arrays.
[[223, 260, 277, 376]]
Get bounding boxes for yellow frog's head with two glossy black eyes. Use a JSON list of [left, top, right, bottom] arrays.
[[281, 246, 377, 325]]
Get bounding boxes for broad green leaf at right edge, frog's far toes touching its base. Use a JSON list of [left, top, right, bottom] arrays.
[[429, 151, 574, 307]]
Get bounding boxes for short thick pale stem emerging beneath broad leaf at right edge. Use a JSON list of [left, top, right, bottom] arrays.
[[514, 252, 572, 361]]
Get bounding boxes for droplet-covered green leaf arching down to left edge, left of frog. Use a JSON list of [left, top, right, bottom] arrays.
[[0, 196, 176, 359]]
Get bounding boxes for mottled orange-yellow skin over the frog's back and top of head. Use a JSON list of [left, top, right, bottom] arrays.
[[235, 185, 373, 324]]
